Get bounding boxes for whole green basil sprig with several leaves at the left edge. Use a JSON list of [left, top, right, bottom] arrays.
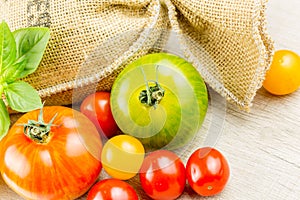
[[0, 21, 50, 140]]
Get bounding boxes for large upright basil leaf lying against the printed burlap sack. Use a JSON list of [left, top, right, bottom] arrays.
[[13, 27, 50, 78]]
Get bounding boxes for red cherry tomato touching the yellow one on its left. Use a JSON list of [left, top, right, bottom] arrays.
[[139, 150, 186, 200]]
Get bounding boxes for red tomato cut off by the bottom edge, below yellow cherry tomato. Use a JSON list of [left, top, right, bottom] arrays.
[[87, 179, 138, 200]]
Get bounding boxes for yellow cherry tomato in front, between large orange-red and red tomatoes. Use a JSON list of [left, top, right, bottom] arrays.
[[101, 135, 145, 180]]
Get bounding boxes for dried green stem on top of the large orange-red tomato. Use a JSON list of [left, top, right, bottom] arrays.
[[24, 107, 57, 143]]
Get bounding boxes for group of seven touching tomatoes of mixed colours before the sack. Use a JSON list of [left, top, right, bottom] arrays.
[[0, 53, 229, 200]]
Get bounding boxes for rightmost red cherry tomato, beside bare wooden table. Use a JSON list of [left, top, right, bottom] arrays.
[[186, 147, 230, 196]]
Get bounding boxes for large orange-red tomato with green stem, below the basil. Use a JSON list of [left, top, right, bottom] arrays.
[[0, 106, 102, 200]]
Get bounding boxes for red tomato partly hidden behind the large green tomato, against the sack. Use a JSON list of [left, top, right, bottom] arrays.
[[80, 91, 119, 138]]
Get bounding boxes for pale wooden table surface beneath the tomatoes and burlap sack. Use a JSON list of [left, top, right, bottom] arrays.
[[0, 0, 300, 200]]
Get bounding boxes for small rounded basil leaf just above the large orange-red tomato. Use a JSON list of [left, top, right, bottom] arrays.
[[4, 81, 42, 112]]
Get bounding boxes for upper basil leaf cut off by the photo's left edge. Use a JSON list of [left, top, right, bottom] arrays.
[[0, 21, 16, 75]]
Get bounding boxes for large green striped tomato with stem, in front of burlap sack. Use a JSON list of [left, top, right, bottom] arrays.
[[111, 53, 208, 150]]
